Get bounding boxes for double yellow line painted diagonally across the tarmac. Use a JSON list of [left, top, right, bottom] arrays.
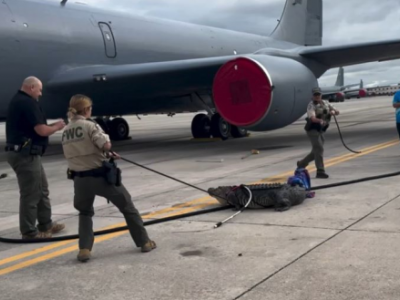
[[0, 140, 399, 276]]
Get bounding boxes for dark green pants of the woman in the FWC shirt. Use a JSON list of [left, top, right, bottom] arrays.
[[74, 177, 149, 250]]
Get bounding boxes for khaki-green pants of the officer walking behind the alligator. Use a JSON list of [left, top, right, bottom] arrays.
[[298, 130, 325, 173]]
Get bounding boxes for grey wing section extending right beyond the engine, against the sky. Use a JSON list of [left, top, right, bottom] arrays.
[[299, 40, 400, 68]]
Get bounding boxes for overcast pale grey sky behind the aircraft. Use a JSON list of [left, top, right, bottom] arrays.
[[80, 0, 400, 86]]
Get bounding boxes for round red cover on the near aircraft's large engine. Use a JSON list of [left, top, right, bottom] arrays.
[[213, 58, 272, 126]]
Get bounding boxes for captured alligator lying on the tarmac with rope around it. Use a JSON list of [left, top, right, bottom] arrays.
[[208, 183, 313, 211]]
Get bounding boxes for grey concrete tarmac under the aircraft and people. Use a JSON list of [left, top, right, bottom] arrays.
[[0, 96, 400, 300]]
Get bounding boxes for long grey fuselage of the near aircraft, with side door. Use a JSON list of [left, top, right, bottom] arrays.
[[0, 0, 295, 119]]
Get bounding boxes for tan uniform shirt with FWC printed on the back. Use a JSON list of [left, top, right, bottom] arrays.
[[62, 116, 110, 172]]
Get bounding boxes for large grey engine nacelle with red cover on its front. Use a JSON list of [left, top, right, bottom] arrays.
[[213, 55, 318, 131]]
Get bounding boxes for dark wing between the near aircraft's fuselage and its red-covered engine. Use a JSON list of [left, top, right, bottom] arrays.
[[46, 56, 234, 103]]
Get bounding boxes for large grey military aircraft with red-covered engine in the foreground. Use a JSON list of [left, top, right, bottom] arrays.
[[0, 0, 400, 140]]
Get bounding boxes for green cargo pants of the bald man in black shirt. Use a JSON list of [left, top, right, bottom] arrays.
[[7, 151, 53, 236]]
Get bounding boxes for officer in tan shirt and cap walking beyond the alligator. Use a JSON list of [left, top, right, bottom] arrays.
[[297, 87, 339, 179]]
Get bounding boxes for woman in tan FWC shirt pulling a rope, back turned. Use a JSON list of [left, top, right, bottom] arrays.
[[62, 95, 156, 262]]
